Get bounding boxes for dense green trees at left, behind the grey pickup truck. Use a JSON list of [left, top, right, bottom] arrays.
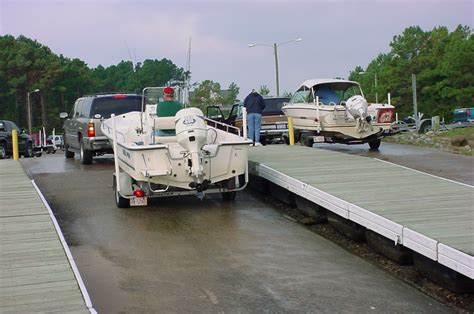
[[0, 35, 186, 133]]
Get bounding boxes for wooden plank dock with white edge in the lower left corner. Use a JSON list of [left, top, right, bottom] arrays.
[[0, 160, 96, 313]]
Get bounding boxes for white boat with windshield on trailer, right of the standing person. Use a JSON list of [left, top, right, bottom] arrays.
[[282, 79, 395, 149]]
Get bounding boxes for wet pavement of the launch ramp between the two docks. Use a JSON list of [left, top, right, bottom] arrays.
[[17, 150, 462, 313]]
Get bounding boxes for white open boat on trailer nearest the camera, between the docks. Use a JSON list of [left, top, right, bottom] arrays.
[[102, 87, 251, 208]]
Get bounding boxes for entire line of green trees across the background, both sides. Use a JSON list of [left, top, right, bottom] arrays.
[[0, 25, 474, 130]]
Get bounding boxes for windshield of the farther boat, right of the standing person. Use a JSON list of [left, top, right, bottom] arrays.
[[290, 82, 363, 105]]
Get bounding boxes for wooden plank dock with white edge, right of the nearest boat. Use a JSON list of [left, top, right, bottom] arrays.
[[249, 145, 474, 285]]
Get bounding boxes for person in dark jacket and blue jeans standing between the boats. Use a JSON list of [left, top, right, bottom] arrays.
[[244, 89, 265, 146]]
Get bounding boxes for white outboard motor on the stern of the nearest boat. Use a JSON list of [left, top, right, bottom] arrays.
[[174, 108, 207, 182]]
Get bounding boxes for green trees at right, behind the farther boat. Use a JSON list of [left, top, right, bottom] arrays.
[[349, 25, 474, 121]]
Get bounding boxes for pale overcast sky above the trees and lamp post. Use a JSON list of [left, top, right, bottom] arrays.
[[0, 0, 474, 98]]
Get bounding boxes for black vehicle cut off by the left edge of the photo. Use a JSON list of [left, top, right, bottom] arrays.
[[0, 120, 33, 159]]
